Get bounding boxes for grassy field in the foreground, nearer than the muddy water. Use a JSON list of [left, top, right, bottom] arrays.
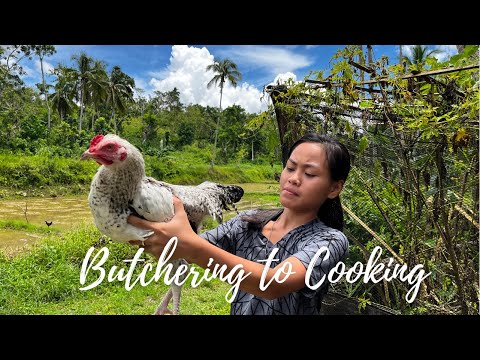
[[0, 183, 279, 315]]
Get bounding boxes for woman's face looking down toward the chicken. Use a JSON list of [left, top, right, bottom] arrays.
[[280, 142, 343, 213]]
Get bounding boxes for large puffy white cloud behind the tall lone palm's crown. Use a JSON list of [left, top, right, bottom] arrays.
[[149, 45, 267, 113]]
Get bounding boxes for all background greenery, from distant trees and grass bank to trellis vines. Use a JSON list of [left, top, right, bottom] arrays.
[[0, 45, 479, 314]]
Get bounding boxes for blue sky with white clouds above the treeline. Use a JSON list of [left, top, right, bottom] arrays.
[[15, 45, 456, 113]]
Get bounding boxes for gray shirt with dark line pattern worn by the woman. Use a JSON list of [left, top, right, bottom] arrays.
[[200, 210, 348, 315]]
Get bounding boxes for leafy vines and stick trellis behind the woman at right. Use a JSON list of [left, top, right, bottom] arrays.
[[259, 45, 479, 314]]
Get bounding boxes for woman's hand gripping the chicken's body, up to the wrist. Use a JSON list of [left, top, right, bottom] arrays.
[[127, 196, 198, 260]]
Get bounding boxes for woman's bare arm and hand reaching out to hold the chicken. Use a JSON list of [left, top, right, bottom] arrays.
[[128, 197, 306, 299]]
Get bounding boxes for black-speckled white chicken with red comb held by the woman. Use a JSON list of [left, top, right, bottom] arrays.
[[81, 134, 243, 315]]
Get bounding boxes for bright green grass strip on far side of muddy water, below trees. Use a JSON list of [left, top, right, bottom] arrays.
[[0, 152, 281, 199]]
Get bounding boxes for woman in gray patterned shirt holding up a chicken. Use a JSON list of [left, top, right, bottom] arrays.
[[129, 134, 350, 314]]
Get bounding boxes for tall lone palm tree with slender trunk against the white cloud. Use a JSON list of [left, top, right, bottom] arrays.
[[207, 59, 242, 169]]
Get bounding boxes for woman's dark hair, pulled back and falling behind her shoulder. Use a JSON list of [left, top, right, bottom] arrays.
[[244, 133, 350, 231]]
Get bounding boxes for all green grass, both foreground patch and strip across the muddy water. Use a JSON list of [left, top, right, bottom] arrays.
[[0, 150, 281, 314]]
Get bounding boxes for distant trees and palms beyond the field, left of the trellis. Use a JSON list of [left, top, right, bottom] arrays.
[[0, 45, 271, 165]]
